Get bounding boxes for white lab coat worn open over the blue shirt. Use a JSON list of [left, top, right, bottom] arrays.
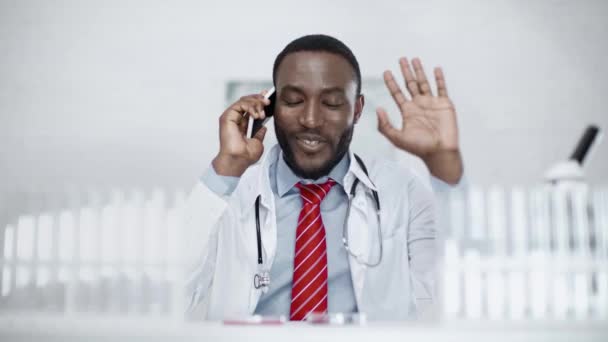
[[184, 145, 437, 320]]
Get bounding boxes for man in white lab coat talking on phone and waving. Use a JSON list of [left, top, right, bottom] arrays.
[[186, 35, 463, 320]]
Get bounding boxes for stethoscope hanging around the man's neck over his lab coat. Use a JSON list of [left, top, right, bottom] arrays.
[[253, 154, 383, 292]]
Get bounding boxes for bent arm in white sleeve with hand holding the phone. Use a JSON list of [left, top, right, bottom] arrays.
[[182, 90, 268, 319]]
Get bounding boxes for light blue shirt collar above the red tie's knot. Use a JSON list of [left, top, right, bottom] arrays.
[[276, 151, 350, 197]]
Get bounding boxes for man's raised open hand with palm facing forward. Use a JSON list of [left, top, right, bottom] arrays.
[[378, 59, 458, 157]]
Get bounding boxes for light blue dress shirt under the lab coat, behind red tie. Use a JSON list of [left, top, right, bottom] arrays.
[[201, 153, 357, 317]]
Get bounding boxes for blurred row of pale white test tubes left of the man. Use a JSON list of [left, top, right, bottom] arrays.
[[0, 189, 185, 317]]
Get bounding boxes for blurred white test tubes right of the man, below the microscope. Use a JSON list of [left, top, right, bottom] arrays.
[[441, 185, 608, 320]]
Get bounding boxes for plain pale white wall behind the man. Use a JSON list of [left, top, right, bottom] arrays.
[[0, 0, 608, 195]]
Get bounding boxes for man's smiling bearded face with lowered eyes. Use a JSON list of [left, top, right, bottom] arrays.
[[274, 50, 364, 179]]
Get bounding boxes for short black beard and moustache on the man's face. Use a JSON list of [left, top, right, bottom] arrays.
[[274, 120, 355, 180]]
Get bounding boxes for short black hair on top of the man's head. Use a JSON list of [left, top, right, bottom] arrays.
[[272, 34, 361, 95]]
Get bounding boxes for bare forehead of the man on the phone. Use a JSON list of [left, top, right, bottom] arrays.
[[276, 51, 356, 91]]
